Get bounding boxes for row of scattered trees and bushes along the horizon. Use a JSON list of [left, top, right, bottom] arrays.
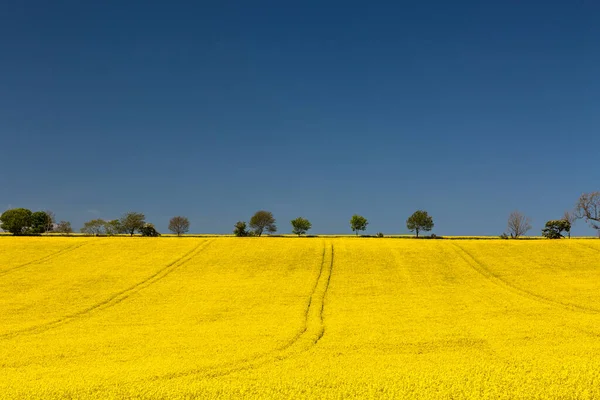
[[0, 192, 600, 239]]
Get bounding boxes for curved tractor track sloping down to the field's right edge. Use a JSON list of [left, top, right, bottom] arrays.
[[450, 243, 600, 314]]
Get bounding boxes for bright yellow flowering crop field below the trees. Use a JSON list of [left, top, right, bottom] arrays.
[[0, 237, 600, 399]]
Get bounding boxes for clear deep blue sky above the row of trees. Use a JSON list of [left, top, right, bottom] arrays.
[[0, 0, 600, 235]]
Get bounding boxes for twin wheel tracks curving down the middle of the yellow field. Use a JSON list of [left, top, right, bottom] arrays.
[[142, 241, 334, 381]]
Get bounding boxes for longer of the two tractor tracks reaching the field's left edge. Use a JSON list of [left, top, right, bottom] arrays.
[[0, 239, 215, 339]]
